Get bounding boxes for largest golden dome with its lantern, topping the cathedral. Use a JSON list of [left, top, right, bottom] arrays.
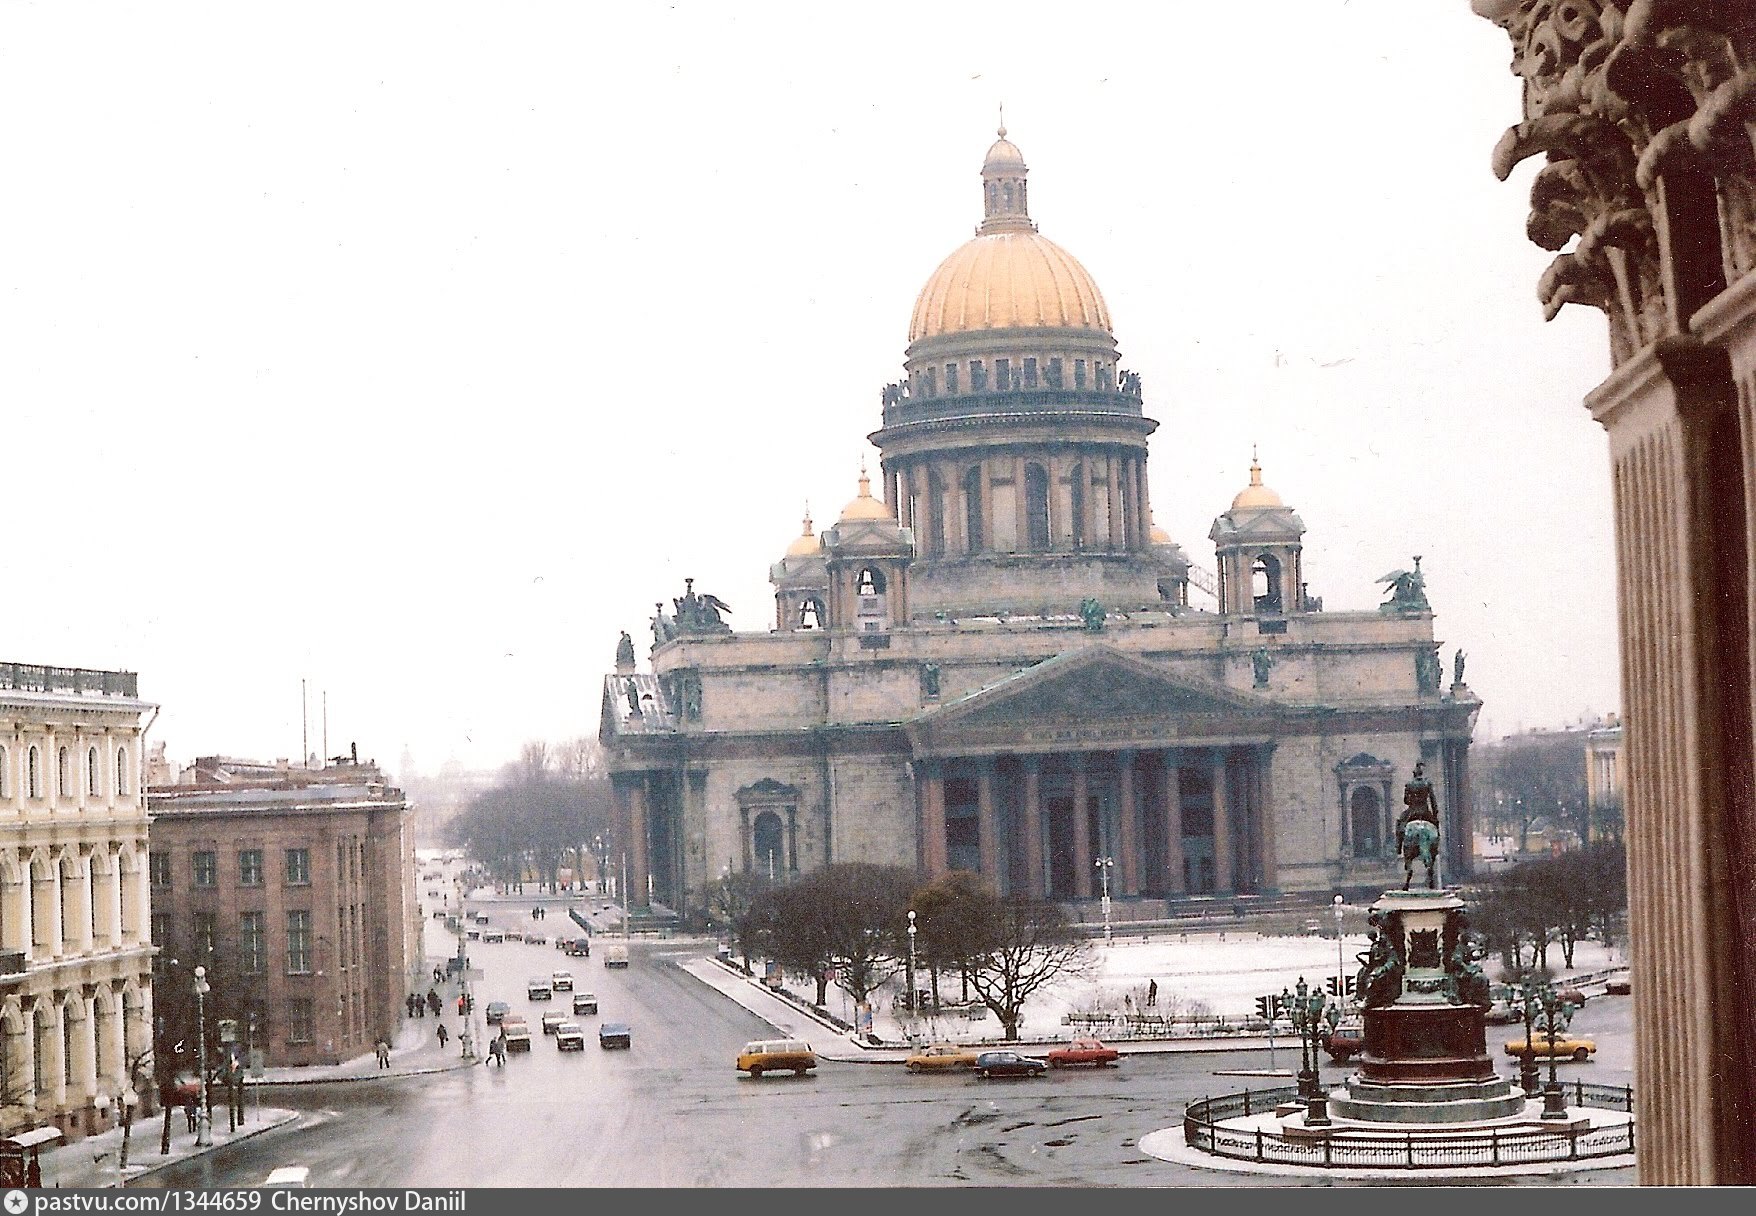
[[908, 127, 1110, 343]]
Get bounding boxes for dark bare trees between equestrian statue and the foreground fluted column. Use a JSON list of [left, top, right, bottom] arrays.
[[1472, 840, 1628, 975]]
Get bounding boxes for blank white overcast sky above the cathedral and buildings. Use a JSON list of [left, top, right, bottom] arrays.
[[0, 0, 1617, 771]]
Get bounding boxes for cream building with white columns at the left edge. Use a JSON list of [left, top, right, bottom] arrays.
[[0, 662, 158, 1137]]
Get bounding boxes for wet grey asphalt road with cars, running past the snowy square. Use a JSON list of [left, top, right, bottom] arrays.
[[137, 940, 1633, 1188]]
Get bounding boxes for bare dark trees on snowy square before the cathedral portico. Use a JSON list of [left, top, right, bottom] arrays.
[[708, 863, 1092, 1039]]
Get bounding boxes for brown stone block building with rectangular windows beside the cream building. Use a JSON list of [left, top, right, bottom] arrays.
[[148, 756, 416, 1067]]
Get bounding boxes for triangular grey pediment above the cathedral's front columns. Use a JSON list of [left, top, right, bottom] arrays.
[[908, 645, 1280, 752]]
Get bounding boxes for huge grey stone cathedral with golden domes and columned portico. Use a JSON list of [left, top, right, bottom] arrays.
[[599, 128, 1480, 917]]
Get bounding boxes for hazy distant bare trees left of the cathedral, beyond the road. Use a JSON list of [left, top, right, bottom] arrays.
[[444, 738, 613, 889]]
